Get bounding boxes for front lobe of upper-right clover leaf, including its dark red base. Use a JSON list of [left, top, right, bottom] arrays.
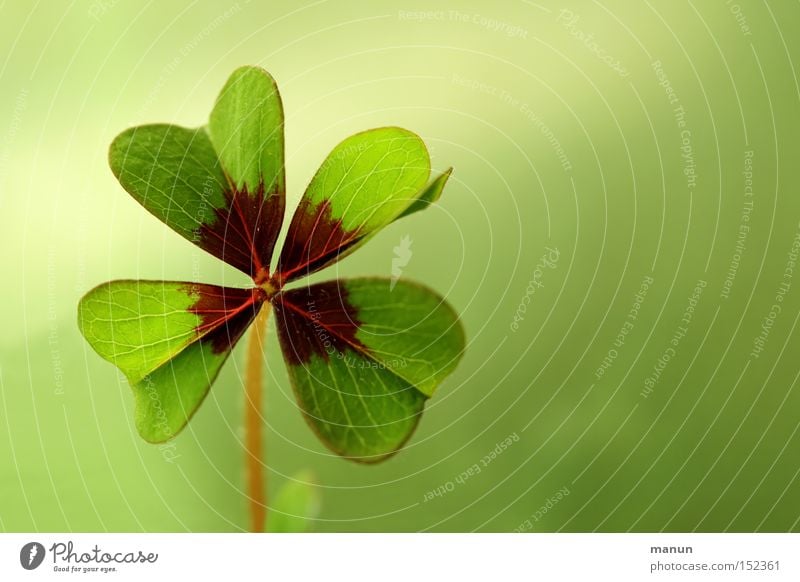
[[277, 127, 438, 281]]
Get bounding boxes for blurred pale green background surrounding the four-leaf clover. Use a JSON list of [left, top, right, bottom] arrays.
[[0, 0, 800, 531]]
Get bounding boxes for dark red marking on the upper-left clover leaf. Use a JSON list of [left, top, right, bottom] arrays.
[[199, 183, 286, 284]]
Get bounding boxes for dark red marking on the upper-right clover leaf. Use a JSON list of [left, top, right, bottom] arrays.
[[277, 200, 360, 283]]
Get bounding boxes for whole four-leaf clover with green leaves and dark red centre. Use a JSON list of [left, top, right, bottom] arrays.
[[78, 66, 464, 532]]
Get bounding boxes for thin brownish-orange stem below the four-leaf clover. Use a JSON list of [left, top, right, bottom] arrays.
[[244, 302, 271, 532]]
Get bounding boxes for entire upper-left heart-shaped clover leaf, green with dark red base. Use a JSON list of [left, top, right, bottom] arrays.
[[109, 67, 286, 283]]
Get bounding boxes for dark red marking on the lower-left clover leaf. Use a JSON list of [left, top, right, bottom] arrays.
[[185, 283, 267, 354]]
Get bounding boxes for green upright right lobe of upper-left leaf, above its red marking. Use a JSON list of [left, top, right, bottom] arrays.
[[208, 66, 286, 193]]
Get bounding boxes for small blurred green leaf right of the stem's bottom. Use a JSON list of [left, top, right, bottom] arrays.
[[267, 471, 320, 533]]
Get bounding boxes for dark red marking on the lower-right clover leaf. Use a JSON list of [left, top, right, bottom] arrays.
[[272, 281, 367, 366]]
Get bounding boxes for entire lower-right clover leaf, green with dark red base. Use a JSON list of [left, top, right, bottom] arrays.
[[273, 278, 464, 462]]
